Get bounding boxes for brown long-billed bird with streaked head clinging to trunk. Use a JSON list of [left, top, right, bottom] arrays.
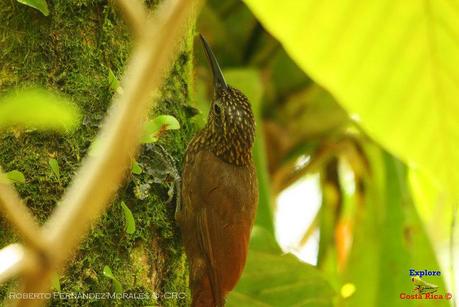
[[175, 35, 258, 307]]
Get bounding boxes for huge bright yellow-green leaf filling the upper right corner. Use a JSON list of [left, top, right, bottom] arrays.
[[244, 0, 459, 201]]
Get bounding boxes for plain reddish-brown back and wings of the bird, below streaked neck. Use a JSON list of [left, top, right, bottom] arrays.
[[178, 151, 258, 306]]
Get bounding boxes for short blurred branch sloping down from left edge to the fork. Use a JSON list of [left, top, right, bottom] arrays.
[[0, 182, 46, 252]]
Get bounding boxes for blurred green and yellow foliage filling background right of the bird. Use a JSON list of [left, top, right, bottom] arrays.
[[194, 0, 459, 306]]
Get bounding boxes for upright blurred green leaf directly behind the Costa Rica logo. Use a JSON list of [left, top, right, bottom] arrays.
[[342, 145, 450, 307]]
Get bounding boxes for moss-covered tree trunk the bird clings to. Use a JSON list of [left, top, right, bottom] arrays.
[[0, 0, 193, 306]]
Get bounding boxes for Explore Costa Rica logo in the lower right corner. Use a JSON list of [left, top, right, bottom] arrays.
[[400, 269, 453, 300]]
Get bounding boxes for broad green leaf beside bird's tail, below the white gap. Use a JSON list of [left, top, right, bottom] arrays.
[[227, 227, 335, 307]]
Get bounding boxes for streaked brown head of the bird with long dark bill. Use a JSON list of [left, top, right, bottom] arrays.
[[201, 35, 255, 164]]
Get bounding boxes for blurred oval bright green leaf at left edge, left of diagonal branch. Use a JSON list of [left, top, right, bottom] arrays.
[[0, 88, 80, 132]]
